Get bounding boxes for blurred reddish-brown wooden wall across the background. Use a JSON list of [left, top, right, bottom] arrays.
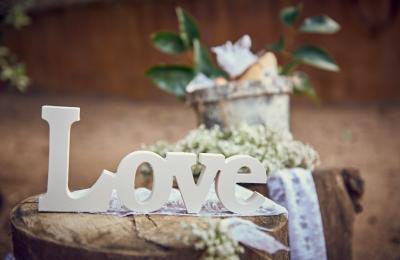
[[5, 0, 400, 101]]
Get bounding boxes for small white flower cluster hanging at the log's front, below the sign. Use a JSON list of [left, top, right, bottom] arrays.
[[183, 218, 244, 260]]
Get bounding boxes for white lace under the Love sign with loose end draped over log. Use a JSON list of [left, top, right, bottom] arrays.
[[107, 185, 289, 254]]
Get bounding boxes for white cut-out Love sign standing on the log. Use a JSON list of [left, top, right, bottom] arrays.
[[39, 106, 267, 214]]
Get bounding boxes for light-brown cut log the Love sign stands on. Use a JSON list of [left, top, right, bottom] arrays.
[[11, 197, 289, 259]]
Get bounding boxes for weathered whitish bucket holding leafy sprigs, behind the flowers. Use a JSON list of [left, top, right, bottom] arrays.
[[187, 81, 290, 130]]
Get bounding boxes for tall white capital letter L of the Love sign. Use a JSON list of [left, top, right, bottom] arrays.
[[39, 106, 114, 212]]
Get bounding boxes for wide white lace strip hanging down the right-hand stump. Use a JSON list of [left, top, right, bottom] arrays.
[[268, 168, 327, 260]]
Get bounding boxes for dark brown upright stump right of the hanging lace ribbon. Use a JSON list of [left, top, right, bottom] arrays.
[[314, 169, 364, 260]]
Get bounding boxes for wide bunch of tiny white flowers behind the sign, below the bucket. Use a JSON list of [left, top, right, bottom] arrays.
[[144, 124, 319, 175]]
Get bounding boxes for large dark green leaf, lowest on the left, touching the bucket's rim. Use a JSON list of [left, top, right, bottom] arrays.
[[146, 65, 195, 98]]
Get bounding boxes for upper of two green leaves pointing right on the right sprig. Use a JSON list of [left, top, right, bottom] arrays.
[[299, 15, 340, 34]]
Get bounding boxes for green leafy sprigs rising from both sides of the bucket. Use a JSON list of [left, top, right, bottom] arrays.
[[147, 4, 340, 100]]
